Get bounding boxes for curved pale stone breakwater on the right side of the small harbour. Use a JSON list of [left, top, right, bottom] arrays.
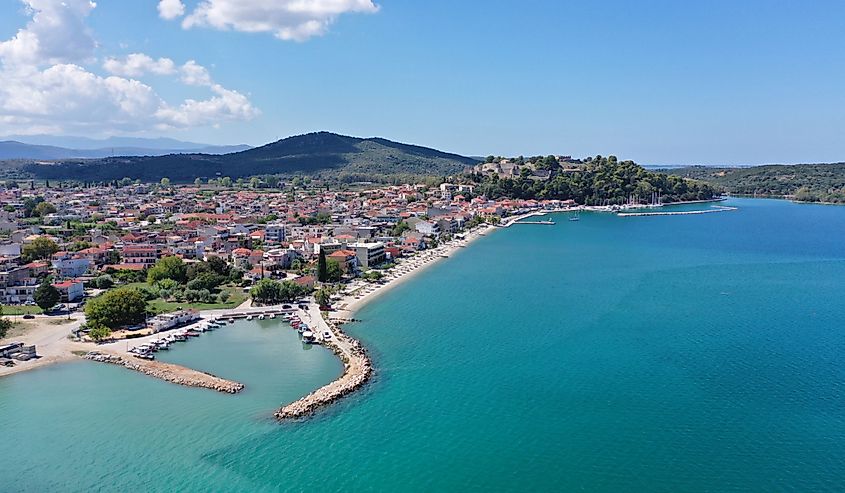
[[275, 320, 373, 421]]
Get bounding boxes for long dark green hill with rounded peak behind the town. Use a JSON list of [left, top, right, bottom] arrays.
[[6, 132, 477, 182]]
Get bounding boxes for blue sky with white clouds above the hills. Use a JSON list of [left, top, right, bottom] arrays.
[[0, 0, 845, 164]]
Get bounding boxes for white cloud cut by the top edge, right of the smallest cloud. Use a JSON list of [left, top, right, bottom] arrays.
[[182, 0, 379, 41]]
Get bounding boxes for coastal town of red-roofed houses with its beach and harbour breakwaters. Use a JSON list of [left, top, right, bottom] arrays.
[[0, 178, 575, 417]]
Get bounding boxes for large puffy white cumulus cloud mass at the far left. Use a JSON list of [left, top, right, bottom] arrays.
[[0, 0, 259, 133]]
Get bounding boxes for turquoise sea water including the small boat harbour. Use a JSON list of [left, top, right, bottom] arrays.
[[0, 200, 845, 491]]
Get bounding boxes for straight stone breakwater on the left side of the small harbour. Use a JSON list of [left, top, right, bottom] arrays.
[[84, 351, 244, 394]]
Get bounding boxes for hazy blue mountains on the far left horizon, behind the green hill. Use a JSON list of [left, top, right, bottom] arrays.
[[0, 135, 250, 160]]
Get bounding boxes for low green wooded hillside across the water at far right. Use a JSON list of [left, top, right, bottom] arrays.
[[667, 163, 845, 203]]
